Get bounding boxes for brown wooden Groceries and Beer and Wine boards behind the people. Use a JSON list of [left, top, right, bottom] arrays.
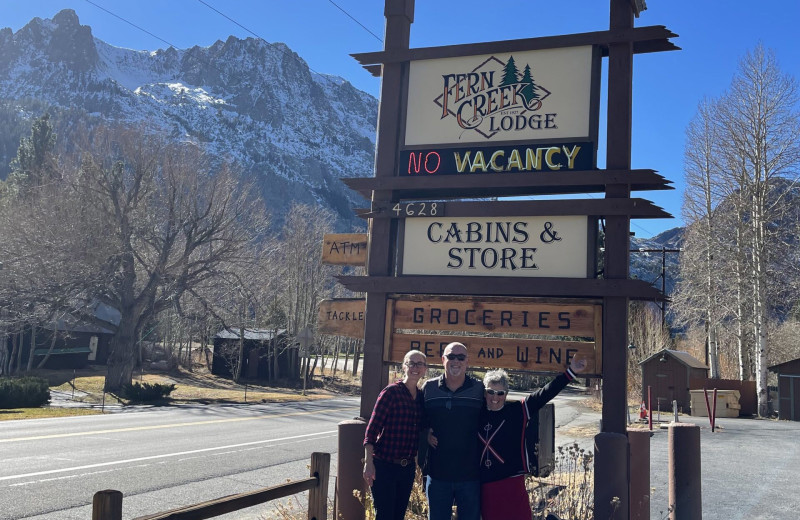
[[383, 295, 603, 377]]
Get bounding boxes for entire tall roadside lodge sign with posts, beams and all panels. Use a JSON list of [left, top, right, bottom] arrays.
[[333, 0, 678, 519]]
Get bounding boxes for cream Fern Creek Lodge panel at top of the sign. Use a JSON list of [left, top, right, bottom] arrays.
[[405, 46, 599, 146]]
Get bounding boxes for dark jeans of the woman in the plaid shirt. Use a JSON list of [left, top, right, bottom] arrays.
[[371, 459, 417, 520]]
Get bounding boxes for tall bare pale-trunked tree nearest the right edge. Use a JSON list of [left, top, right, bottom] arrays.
[[682, 45, 800, 416]]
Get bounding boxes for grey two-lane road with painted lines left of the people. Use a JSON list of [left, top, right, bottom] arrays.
[[0, 398, 358, 520]]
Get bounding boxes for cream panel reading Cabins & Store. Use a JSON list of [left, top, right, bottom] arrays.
[[402, 215, 590, 278]]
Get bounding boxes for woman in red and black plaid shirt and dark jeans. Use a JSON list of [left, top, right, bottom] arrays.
[[364, 350, 427, 520]]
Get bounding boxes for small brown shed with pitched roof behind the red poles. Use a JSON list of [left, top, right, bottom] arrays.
[[639, 349, 708, 413]]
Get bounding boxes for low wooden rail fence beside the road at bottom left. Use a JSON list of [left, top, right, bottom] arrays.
[[92, 452, 331, 520]]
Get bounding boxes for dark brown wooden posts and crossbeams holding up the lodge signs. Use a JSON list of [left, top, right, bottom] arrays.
[[346, 5, 680, 518]]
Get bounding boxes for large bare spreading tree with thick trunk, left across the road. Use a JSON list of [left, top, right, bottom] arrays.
[[0, 126, 266, 391]]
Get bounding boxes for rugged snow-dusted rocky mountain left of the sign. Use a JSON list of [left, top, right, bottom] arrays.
[[0, 9, 378, 228]]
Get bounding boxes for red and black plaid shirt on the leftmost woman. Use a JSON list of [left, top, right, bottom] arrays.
[[364, 381, 424, 461]]
